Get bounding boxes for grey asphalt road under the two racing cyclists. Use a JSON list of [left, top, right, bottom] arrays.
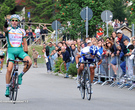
[[0, 68, 135, 110]]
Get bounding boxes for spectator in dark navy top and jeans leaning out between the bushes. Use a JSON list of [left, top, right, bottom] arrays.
[[61, 46, 70, 78]]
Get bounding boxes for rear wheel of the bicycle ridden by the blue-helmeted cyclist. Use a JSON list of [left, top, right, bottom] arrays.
[[80, 72, 85, 99]]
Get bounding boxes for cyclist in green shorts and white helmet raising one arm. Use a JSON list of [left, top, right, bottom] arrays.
[[3, 14, 32, 97]]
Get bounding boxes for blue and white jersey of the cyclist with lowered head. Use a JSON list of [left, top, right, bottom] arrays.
[[80, 46, 101, 62]]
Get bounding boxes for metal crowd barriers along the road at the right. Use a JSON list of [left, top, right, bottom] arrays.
[[94, 56, 135, 90]]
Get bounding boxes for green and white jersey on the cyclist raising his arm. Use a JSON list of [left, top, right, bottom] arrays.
[[6, 27, 26, 48]]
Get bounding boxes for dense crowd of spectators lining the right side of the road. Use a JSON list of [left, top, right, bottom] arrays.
[[42, 30, 135, 79]]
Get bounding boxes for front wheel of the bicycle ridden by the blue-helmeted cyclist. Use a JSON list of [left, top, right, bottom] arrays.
[[86, 73, 92, 100]]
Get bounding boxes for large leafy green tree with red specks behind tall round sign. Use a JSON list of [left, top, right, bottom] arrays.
[[55, 0, 107, 39]]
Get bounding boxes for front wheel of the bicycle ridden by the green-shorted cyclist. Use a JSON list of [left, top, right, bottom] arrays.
[[12, 73, 18, 101]]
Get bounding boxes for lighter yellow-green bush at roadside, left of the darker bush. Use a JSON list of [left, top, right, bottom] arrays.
[[54, 58, 66, 73]]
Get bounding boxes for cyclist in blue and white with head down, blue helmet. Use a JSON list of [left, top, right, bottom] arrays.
[[76, 42, 102, 88]]
